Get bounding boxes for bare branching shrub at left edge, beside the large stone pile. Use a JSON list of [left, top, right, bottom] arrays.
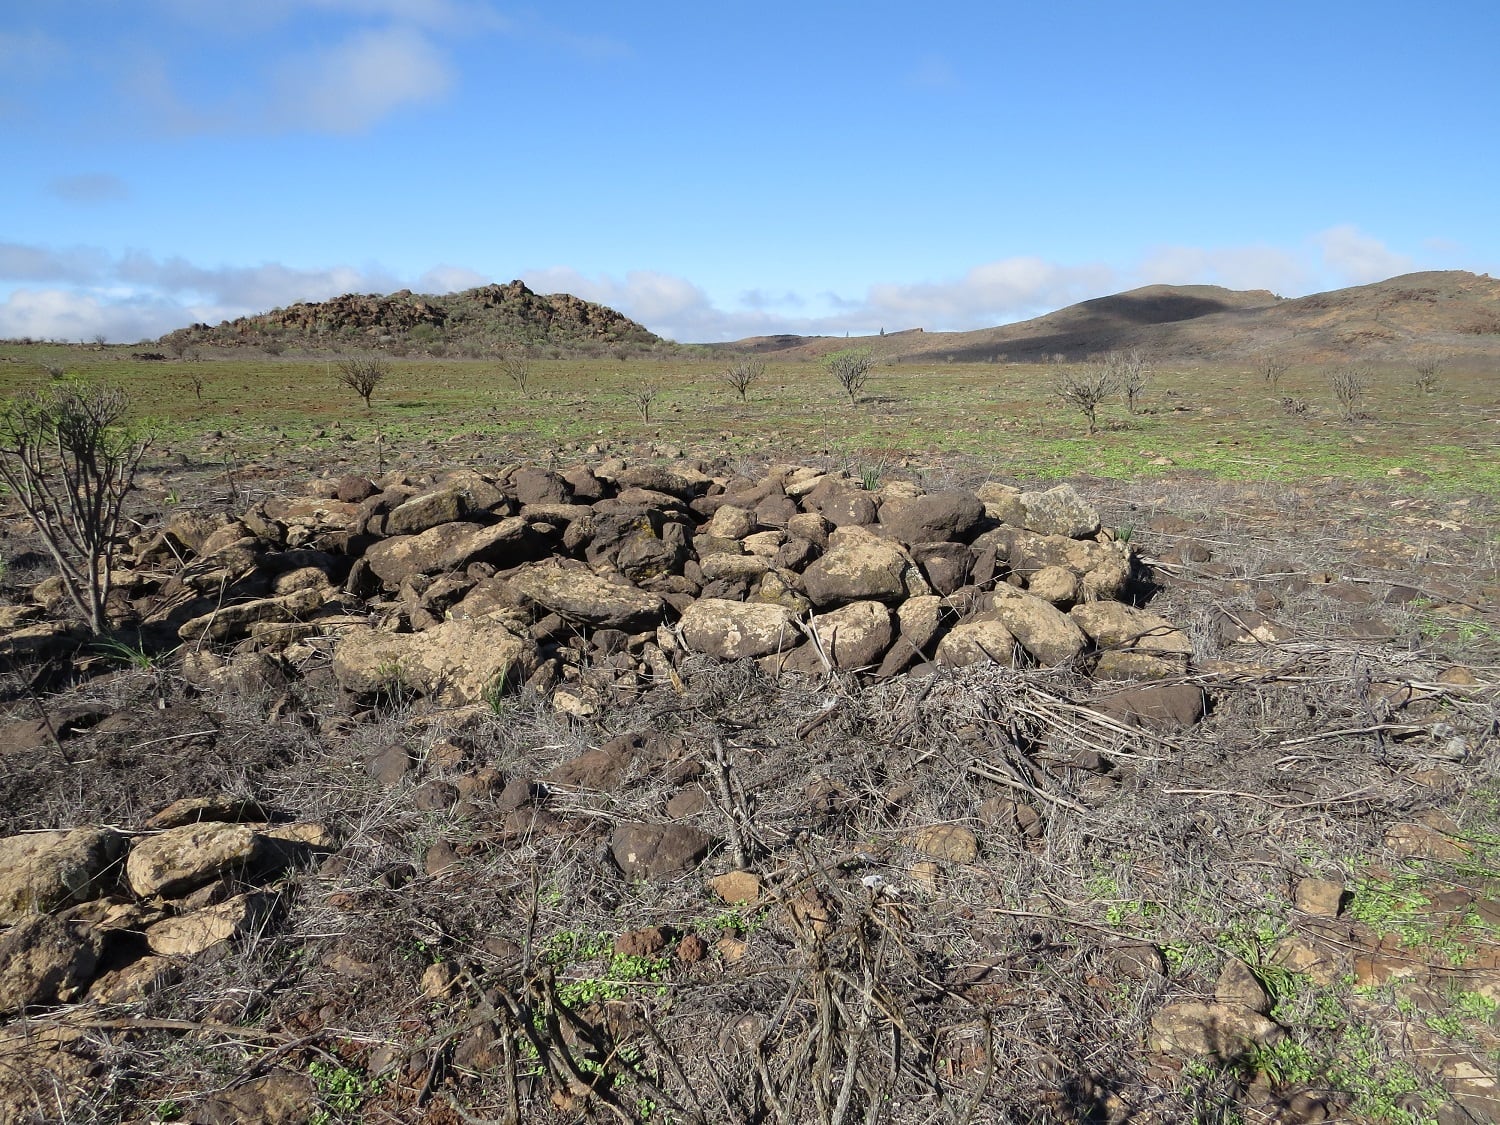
[[0, 381, 149, 635]]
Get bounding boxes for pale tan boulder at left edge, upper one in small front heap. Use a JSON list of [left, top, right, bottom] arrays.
[[0, 828, 125, 926]]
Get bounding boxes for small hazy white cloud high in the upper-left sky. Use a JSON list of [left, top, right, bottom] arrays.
[[272, 27, 455, 134]]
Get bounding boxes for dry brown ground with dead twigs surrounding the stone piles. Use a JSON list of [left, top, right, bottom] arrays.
[[0, 450, 1500, 1125]]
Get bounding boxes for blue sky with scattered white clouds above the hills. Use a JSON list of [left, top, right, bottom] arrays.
[[0, 0, 1500, 341]]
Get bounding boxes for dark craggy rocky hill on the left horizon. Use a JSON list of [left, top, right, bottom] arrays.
[[161, 281, 665, 356]]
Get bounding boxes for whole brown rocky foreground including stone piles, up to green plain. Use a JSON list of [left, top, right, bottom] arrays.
[[0, 450, 1500, 1125]]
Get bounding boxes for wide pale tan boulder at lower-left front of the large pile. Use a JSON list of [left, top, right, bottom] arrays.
[[333, 618, 537, 704]]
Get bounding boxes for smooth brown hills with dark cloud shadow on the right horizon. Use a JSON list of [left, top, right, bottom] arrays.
[[728, 270, 1500, 363]]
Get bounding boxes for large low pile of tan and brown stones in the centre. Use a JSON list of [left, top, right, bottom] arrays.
[[73, 461, 1191, 714]]
